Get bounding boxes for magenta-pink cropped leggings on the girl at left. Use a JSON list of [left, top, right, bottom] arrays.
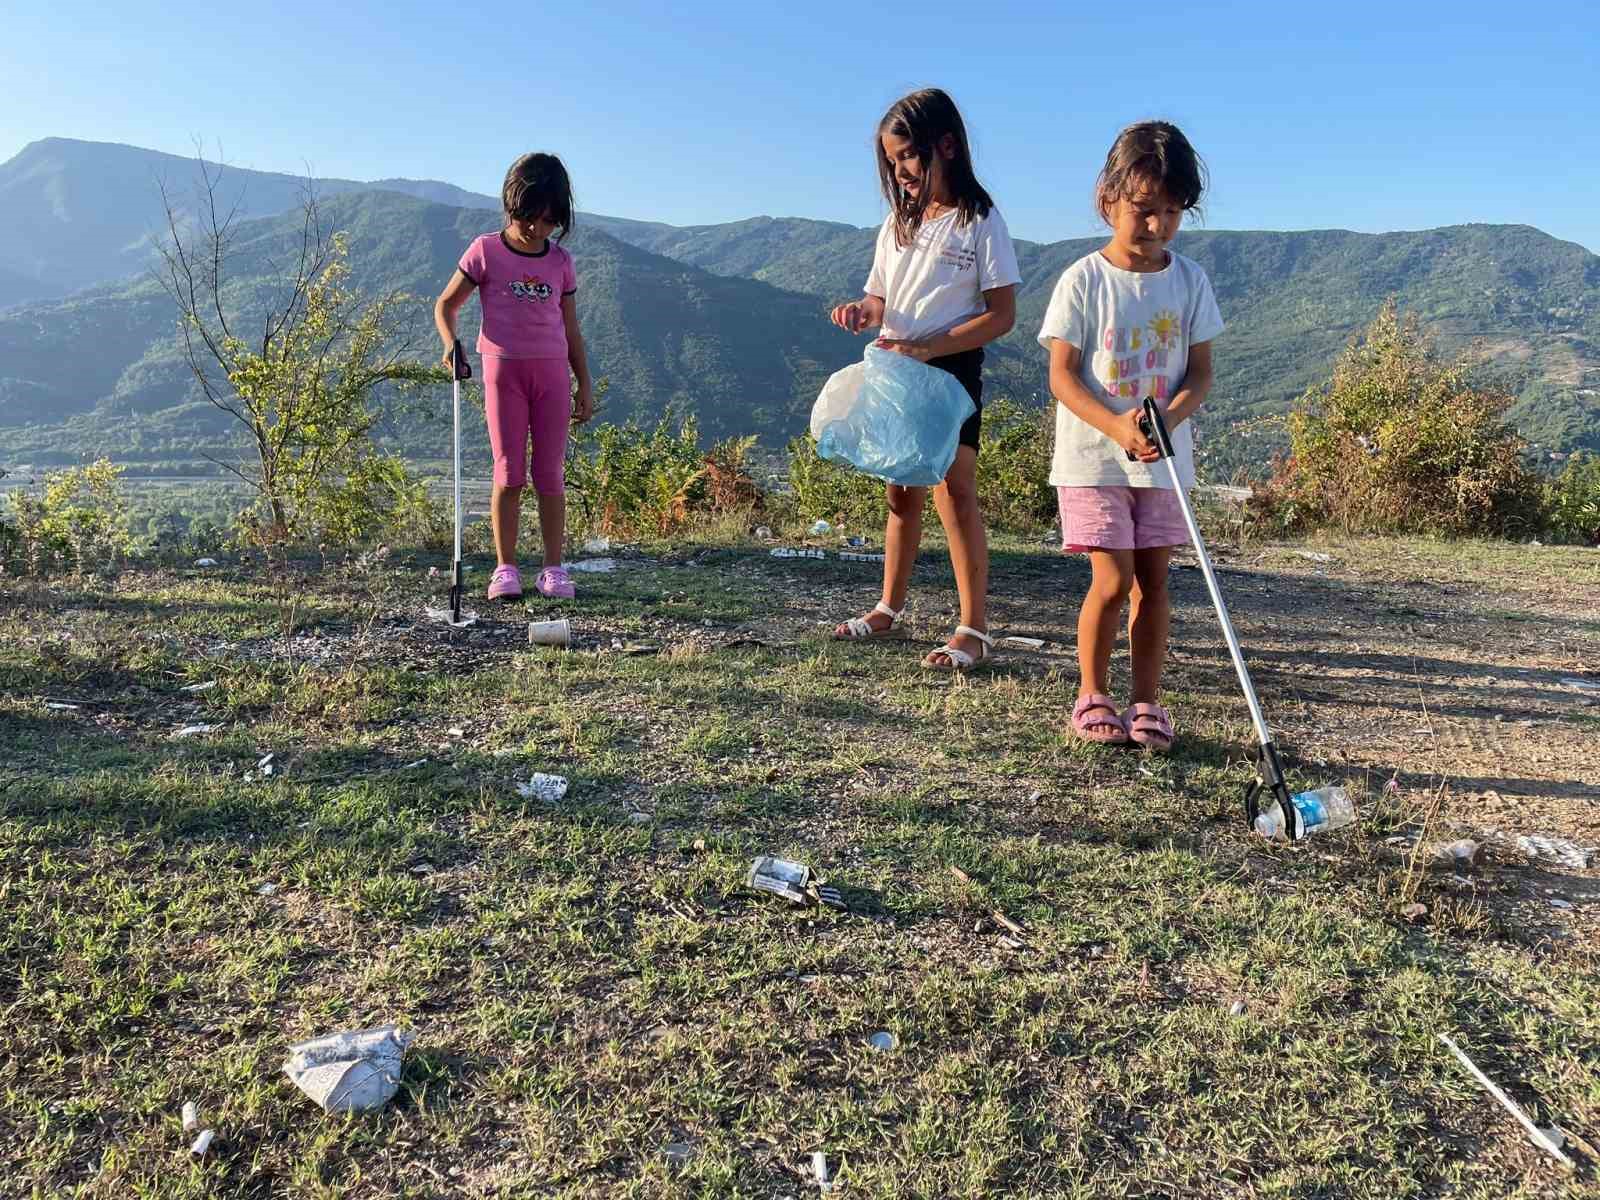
[[483, 354, 573, 496]]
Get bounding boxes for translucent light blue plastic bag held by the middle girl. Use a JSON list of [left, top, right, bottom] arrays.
[[811, 346, 978, 488]]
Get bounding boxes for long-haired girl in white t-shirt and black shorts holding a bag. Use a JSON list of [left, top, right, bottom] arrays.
[[832, 88, 1022, 670]]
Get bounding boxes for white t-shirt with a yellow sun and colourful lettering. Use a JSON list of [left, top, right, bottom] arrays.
[[1038, 251, 1222, 490]]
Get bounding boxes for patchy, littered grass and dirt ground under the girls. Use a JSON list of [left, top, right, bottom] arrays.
[[0, 541, 1600, 1200]]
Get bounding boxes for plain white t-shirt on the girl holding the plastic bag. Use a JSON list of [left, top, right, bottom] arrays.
[[867, 208, 1022, 341]]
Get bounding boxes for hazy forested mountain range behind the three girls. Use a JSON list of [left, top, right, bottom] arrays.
[[0, 138, 1600, 470]]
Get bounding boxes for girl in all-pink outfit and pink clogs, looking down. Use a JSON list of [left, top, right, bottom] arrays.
[[434, 154, 594, 600]]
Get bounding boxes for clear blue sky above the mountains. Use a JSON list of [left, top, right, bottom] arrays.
[[0, 0, 1600, 251]]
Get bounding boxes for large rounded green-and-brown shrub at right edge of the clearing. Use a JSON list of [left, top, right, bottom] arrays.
[[1258, 299, 1541, 536]]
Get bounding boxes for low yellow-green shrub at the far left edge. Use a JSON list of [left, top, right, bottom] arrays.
[[0, 459, 133, 574]]
